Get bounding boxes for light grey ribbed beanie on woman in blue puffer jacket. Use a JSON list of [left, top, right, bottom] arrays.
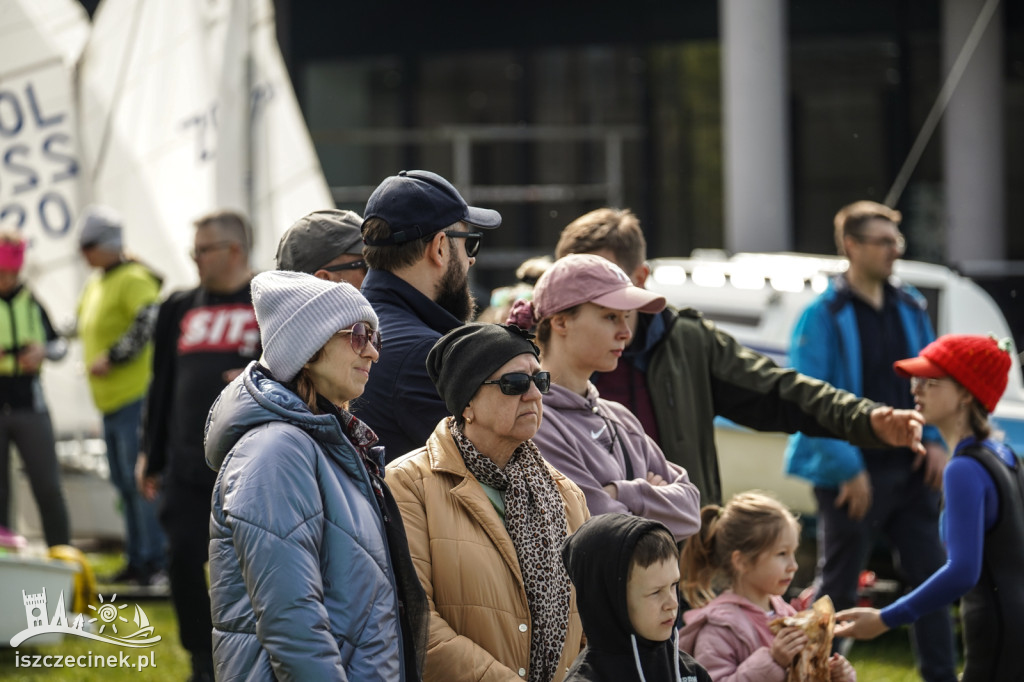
[[252, 270, 378, 382]]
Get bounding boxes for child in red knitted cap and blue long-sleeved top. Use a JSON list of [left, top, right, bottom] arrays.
[[836, 334, 1024, 682]]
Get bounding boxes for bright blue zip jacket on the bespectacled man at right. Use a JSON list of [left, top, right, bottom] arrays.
[[785, 275, 941, 487]]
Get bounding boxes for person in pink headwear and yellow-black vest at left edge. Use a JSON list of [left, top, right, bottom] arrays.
[[0, 231, 70, 547]]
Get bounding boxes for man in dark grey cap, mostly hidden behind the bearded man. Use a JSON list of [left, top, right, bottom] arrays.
[[278, 209, 367, 289]]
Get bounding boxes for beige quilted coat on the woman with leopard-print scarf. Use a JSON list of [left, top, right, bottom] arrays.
[[387, 421, 590, 682]]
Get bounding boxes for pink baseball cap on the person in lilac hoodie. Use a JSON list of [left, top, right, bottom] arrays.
[[532, 254, 665, 319]]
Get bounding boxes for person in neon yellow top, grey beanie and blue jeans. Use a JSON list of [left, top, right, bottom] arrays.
[[77, 206, 164, 585]]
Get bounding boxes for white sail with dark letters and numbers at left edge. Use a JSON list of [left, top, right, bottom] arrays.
[[0, 0, 98, 433]]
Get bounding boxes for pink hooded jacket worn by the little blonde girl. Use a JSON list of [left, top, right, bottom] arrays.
[[679, 592, 797, 682]]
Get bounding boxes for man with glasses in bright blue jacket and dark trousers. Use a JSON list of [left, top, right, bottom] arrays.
[[785, 201, 956, 681]]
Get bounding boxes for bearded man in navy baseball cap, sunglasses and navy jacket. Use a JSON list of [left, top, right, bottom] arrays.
[[360, 170, 502, 461]]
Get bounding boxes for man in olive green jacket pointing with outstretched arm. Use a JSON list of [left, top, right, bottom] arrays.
[[555, 208, 924, 504]]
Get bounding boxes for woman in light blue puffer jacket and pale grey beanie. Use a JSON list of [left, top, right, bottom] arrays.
[[206, 271, 427, 680]]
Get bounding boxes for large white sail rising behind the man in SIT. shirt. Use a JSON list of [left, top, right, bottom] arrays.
[[80, 0, 333, 288]]
